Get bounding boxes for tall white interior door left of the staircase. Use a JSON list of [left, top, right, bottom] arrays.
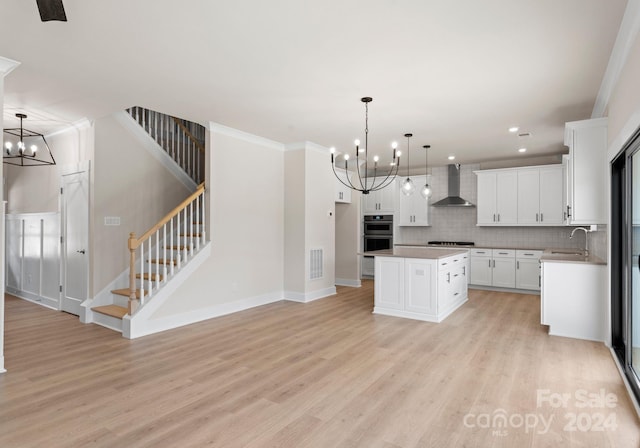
[[61, 171, 89, 315]]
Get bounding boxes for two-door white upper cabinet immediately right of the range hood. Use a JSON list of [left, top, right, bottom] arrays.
[[475, 170, 518, 226]]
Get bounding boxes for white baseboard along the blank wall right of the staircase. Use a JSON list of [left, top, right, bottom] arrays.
[[122, 291, 282, 339]]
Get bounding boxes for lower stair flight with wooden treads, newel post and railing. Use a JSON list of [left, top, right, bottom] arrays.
[[91, 183, 206, 331]]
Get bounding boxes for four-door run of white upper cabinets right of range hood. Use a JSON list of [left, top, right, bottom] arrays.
[[475, 164, 564, 226]]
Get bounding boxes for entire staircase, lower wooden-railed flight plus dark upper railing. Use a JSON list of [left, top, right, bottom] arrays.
[[85, 106, 206, 335]]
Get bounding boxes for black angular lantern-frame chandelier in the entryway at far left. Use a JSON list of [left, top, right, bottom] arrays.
[[2, 114, 56, 166]]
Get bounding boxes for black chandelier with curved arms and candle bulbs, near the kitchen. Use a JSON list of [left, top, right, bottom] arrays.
[[331, 96, 402, 194]]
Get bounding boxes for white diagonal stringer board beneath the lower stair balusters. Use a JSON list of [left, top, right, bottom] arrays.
[[122, 242, 211, 339]]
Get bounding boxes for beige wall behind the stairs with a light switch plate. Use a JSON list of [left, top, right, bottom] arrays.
[[89, 116, 191, 296]]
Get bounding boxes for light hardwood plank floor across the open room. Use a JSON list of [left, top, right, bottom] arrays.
[[0, 282, 640, 448]]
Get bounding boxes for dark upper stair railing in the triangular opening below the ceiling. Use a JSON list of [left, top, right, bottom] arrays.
[[127, 106, 205, 184]]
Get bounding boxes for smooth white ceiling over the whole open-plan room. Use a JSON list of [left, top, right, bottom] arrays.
[[0, 0, 627, 165]]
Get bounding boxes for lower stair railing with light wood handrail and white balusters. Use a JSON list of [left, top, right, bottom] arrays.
[[128, 182, 206, 316]]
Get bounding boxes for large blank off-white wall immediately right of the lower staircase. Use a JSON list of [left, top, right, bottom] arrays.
[[152, 124, 285, 319]]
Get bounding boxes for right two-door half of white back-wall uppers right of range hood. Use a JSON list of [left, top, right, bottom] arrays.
[[517, 165, 563, 226]]
